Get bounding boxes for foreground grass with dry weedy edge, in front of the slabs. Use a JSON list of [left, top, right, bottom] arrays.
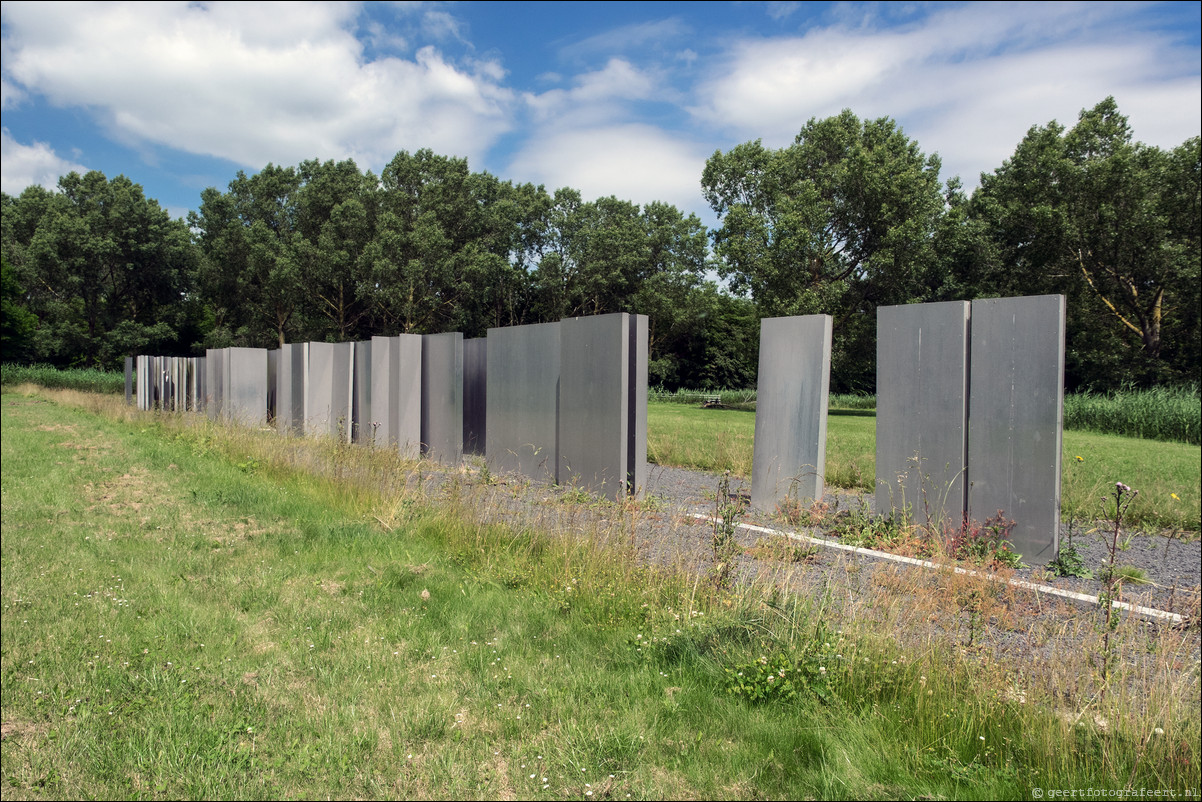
[[0, 390, 1202, 800]]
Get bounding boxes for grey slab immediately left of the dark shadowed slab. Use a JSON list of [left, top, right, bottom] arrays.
[[421, 332, 463, 464]]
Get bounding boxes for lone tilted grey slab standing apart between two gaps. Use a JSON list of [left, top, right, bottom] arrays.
[[751, 315, 832, 512]]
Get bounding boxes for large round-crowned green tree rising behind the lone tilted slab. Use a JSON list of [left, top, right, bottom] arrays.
[[702, 111, 944, 390]]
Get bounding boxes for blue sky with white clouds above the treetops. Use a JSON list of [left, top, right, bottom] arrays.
[[0, 1, 1202, 226]]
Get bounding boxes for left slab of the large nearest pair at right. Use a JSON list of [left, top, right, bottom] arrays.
[[876, 301, 969, 530]]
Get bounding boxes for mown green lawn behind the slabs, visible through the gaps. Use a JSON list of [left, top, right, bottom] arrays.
[[647, 403, 1202, 533]]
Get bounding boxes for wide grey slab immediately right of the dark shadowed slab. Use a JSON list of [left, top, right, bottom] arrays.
[[484, 323, 561, 482]]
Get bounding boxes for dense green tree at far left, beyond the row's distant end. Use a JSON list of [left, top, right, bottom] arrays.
[[5, 171, 197, 367]]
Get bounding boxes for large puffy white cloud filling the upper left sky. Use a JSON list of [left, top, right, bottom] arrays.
[[4, 2, 513, 168]]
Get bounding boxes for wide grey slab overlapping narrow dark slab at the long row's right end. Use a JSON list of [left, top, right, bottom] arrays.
[[559, 313, 629, 498]]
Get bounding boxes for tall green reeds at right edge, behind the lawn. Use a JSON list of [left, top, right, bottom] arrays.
[[1064, 385, 1202, 445]]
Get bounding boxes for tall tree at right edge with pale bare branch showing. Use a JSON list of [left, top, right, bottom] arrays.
[[969, 97, 1202, 387]]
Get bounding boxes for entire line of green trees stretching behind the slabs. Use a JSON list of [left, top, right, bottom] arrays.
[[0, 99, 1202, 392]]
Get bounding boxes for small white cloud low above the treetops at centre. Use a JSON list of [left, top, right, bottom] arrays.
[[506, 124, 712, 210]]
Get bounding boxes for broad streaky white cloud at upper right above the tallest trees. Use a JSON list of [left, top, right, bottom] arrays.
[[690, 4, 1202, 181]]
